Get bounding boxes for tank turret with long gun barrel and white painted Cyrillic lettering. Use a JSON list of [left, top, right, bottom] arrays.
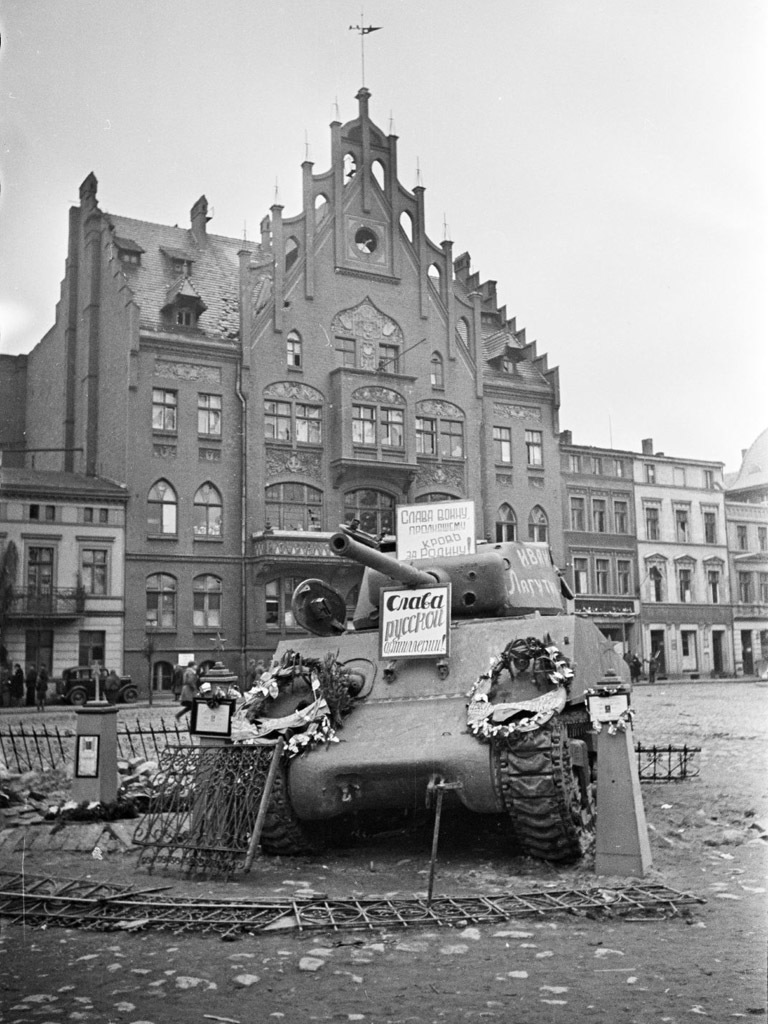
[[329, 530, 563, 629]]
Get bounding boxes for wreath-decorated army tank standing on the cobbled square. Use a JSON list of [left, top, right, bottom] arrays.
[[243, 528, 629, 862]]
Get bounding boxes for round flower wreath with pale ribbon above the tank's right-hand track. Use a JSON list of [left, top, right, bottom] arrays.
[[467, 635, 573, 741]]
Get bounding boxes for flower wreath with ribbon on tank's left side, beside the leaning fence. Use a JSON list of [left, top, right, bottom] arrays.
[[231, 650, 355, 758]]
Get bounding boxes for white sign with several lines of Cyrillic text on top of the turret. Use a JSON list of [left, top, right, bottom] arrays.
[[395, 502, 475, 561]]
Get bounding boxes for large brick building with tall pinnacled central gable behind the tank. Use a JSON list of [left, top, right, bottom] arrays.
[[3, 88, 564, 687]]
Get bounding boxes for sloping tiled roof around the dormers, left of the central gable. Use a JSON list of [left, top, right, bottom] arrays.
[[104, 213, 262, 341]]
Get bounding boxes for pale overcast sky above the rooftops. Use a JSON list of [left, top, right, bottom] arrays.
[[0, 0, 768, 471]]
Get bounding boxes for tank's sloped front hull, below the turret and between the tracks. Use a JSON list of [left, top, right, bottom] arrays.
[[275, 614, 629, 821]]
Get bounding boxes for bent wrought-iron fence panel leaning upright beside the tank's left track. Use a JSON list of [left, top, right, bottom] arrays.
[[133, 746, 273, 877]]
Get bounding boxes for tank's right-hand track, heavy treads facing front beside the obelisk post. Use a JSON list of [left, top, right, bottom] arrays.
[[492, 713, 595, 862]]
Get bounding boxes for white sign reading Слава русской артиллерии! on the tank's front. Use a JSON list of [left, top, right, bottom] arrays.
[[379, 584, 451, 658]]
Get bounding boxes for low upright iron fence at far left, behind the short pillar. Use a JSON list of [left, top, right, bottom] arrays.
[[0, 719, 189, 772]]
